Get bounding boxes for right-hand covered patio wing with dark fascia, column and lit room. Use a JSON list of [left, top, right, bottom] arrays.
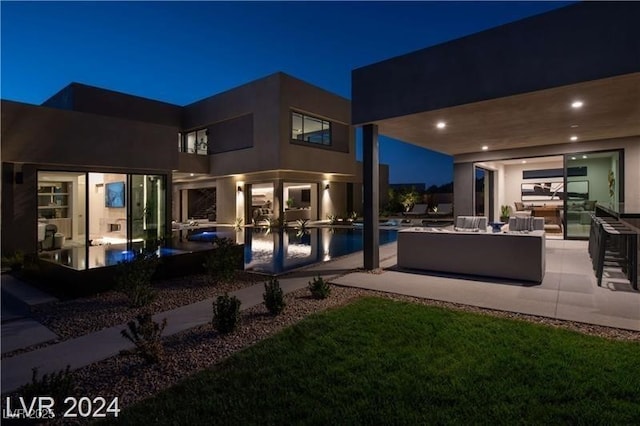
[[352, 2, 640, 269]]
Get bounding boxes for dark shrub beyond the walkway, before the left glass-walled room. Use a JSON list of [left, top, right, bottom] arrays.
[[115, 252, 159, 308]]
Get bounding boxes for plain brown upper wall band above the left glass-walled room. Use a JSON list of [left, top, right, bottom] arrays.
[[2, 101, 178, 170]]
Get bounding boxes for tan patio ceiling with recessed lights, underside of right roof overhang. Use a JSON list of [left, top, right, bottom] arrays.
[[373, 73, 640, 155]]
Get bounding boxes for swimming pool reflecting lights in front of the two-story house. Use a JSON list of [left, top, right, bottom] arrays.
[[188, 228, 398, 274]]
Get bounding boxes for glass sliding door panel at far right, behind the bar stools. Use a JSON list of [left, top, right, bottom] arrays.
[[564, 151, 621, 239]]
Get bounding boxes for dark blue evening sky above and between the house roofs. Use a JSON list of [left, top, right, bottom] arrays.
[[0, 1, 568, 185]]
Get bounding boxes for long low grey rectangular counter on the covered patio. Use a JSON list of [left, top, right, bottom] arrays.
[[398, 228, 545, 282]]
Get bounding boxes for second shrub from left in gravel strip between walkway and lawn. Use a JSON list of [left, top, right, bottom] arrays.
[[120, 313, 167, 364]]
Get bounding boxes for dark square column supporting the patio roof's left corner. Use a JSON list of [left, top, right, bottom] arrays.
[[362, 124, 380, 270]]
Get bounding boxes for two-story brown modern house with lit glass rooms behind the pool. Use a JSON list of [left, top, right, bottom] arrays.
[[2, 73, 387, 262]]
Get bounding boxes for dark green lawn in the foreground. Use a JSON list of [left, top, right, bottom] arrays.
[[112, 298, 640, 425]]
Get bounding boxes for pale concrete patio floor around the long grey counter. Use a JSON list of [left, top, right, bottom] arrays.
[[332, 239, 640, 331]]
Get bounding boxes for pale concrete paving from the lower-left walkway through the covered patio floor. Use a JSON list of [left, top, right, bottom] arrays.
[[2, 239, 640, 392]]
